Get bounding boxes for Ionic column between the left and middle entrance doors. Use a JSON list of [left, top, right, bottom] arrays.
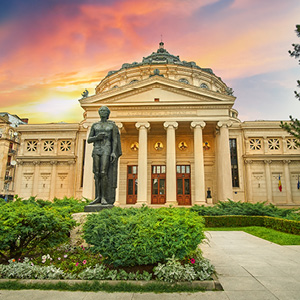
[[135, 122, 150, 205]]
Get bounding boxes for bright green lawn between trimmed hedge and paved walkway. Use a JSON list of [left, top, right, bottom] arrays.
[[205, 226, 300, 246]]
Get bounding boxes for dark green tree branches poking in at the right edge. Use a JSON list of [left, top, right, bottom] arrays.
[[280, 25, 300, 146]]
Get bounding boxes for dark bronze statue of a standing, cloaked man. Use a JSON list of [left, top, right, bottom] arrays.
[[87, 106, 122, 205]]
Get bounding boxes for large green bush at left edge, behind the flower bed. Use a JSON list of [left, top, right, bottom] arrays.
[[0, 199, 76, 260]]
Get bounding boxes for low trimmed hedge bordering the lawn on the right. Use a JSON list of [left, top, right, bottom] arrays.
[[203, 216, 300, 235]]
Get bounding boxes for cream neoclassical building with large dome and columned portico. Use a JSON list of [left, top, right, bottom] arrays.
[[7, 42, 300, 206]]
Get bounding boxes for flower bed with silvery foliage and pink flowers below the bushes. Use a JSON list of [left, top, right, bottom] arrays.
[[0, 245, 214, 283]]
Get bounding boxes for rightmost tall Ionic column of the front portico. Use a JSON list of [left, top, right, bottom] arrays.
[[217, 121, 233, 201]]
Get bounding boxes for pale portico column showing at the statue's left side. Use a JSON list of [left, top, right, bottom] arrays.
[[82, 127, 95, 199]]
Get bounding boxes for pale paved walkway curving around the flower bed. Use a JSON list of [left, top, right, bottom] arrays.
[[0, 231, 300, 300]]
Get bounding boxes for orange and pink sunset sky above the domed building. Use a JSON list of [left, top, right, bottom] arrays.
[[0, 0, 300, 124]]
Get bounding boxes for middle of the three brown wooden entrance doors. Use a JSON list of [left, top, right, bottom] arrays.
[[151, 166, 166, 204]]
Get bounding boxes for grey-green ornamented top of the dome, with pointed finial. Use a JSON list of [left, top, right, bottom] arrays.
[[106, 42, 215, 77]]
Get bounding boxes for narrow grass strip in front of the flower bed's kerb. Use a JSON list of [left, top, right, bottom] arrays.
[[0, 280, 205, 293]]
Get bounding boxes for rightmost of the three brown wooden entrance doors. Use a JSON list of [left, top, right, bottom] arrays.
[[176, 165, 191, 205]]
